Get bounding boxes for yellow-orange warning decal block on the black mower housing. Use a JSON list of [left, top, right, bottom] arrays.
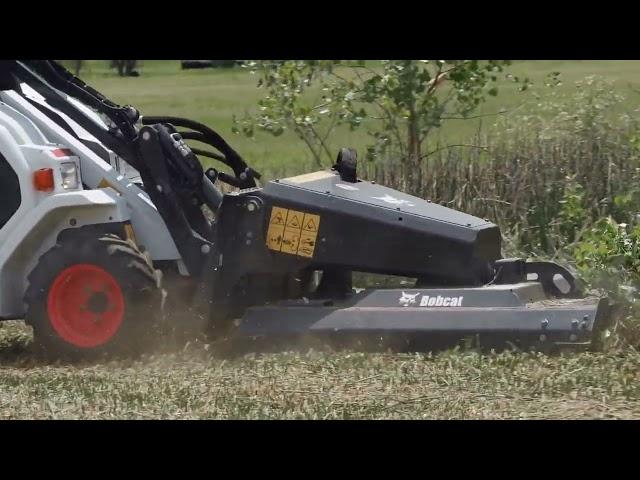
[[267, 207, 320, 258]]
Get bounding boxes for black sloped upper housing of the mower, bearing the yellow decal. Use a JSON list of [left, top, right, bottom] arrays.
[[217, 171, 501, 286]]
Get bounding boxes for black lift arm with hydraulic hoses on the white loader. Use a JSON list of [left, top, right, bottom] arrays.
[[3, 60, 260, 276]]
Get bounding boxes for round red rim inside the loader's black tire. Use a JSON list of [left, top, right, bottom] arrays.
[[47, 264, 124, 348]]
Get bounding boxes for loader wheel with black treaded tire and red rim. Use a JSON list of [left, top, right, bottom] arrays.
[[25, 234, 164, 360]]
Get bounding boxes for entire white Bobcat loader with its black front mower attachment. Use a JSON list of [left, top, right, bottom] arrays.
[[0, 60, 610, 356]]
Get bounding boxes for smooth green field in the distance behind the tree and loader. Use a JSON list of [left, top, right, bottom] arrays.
[[70, 61, 640, 178]]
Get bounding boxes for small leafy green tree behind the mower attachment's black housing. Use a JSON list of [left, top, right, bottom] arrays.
[[234, 60, 528, 191]]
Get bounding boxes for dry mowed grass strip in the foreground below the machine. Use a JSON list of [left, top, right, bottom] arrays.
[[0, 322, 640, 419]]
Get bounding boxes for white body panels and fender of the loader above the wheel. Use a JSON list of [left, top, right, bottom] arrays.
[[0, 79, 180, 319]]
